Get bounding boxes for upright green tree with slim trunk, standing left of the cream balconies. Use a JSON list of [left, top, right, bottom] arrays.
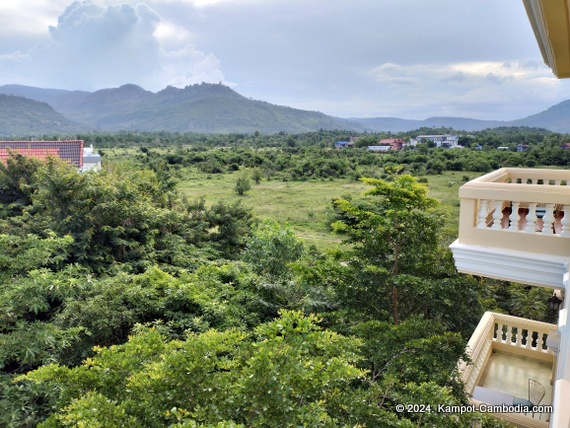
[[332, 174, 442, 324]]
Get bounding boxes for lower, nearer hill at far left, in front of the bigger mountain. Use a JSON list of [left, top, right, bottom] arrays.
[[0, 94, 90, 137]]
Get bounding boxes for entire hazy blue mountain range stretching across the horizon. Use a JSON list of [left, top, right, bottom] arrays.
[[0, 83, 570, 136]]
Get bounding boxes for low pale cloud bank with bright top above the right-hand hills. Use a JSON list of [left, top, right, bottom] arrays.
[[364, 60, 563, 120]]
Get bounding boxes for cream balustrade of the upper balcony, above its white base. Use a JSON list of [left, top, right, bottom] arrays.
[[458, 168, 570, 256]]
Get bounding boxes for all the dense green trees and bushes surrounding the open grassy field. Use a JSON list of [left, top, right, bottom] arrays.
[[0, 125, 554, 427]]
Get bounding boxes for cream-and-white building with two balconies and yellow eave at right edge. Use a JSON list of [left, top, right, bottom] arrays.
[[450, 0, 570, 428]]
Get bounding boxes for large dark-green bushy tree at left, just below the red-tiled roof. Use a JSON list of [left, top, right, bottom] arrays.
[[7, 159, 200, 272]]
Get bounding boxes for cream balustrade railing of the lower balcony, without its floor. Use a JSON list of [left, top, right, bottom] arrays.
[[459, 312, 556, 427]]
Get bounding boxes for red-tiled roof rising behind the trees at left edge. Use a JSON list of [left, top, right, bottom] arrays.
[[0, 140, 83, 169]]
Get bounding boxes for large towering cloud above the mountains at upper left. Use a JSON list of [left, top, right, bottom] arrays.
[[0, 1, 231, 91]]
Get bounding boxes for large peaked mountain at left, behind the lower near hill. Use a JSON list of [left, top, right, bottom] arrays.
[[0, 83, 364, 133]]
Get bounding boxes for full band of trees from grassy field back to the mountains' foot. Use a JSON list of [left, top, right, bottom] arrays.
[[55, 127, 570, 181]]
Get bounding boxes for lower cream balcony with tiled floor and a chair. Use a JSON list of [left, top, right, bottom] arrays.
[[459, 312, 557, 428]]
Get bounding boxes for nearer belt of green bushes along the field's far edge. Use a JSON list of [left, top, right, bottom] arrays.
[[134, 143, 570, 181]]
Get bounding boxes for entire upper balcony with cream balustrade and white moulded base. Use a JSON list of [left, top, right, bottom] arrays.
[[450, 168, 570, 289]]
